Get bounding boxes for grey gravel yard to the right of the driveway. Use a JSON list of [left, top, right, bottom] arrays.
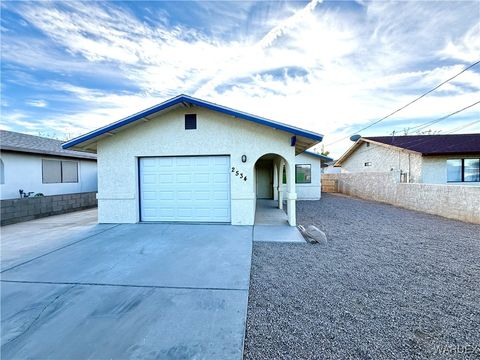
[[244, 194, 480, 359]]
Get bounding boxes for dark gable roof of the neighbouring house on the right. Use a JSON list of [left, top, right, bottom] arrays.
[[335, 134, 480, 166]]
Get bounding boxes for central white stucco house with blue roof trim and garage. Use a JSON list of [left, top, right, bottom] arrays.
[[63, 95, 323, 226]]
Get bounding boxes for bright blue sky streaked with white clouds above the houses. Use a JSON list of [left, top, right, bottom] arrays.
[[1, 1, 480, 156]]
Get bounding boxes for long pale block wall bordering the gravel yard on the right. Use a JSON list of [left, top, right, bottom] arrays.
[[322, 172, 480, 224]]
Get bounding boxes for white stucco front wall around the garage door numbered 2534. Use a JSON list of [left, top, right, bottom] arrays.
[[97, 107, 295, 225]]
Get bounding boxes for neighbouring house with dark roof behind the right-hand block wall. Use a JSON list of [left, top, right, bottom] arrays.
[[335, 134, 480, 185]]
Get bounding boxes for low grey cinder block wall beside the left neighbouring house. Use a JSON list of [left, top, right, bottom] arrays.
[[0, 192, 97, 226]]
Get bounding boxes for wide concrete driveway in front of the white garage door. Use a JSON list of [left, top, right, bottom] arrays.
[[1, 211, 252, 359]]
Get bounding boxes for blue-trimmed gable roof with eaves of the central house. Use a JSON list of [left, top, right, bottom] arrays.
[[63, 94, 323, 153]]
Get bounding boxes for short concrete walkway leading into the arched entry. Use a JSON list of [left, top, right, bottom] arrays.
[[253, 199, 305, 243]]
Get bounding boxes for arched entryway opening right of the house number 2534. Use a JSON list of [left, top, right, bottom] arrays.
[[254, 154, 296, 226]]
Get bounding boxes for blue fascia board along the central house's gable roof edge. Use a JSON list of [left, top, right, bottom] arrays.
[[62, 95, 323, 149]]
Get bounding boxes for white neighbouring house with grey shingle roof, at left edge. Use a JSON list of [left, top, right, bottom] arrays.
[[0, 130, 97, 200]]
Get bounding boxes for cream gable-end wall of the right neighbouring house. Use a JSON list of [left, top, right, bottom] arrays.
[[342, 143, 422, 182]]
